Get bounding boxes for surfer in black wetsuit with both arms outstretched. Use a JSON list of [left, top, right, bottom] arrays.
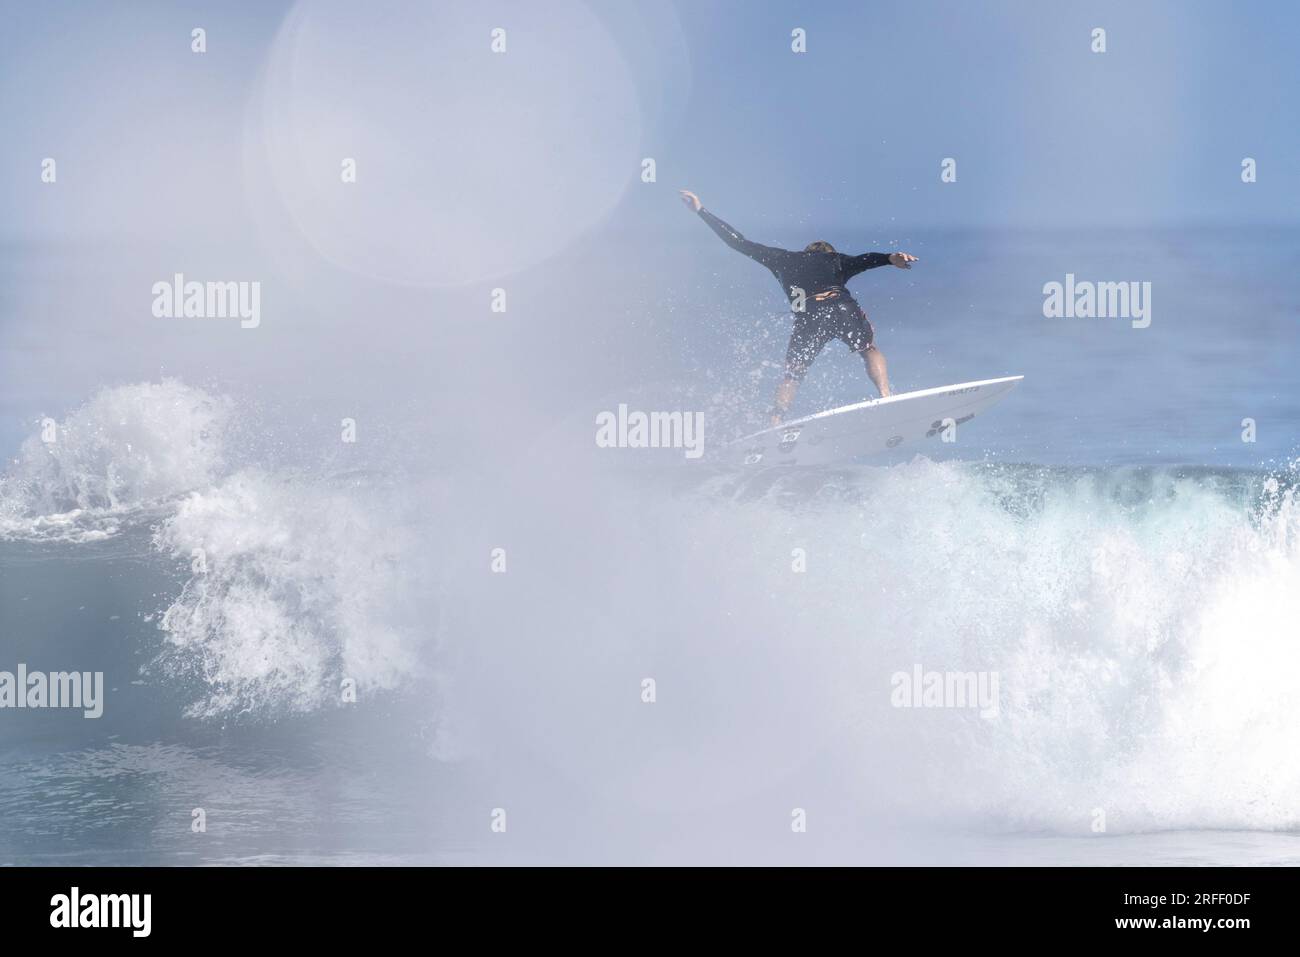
[[681, 190, 918, 425]]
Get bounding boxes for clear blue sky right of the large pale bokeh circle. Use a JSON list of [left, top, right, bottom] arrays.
[[650, 0, 1300, 226]]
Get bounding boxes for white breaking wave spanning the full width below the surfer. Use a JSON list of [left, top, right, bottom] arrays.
[[0, 380, 1300, 833]]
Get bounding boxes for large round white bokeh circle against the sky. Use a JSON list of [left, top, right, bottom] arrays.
[[252, 0, 642, 286]]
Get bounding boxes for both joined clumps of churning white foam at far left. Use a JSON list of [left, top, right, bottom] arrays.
[[0, 380, 432, 715]]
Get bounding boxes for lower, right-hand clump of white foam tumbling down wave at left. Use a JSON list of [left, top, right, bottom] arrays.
[[156, 469, 432, 715]]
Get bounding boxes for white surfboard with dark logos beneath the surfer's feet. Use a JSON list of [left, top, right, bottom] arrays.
[[712, 376, 1024, 468]]
